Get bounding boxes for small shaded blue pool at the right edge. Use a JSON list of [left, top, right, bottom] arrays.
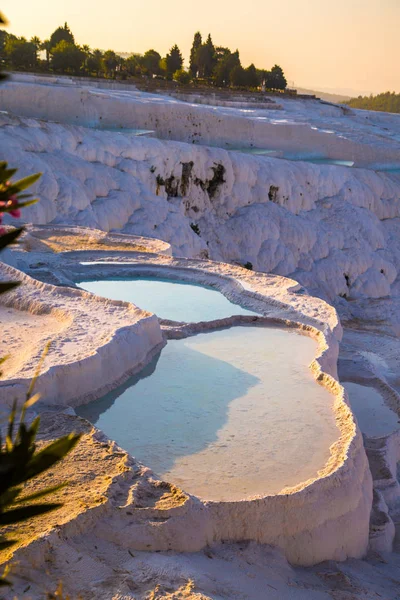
[[343, 383, 400, 437]]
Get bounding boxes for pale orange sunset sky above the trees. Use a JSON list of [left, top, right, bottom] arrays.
[[1, 0, 400, 93]]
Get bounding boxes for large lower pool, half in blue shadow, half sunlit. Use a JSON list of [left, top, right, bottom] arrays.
[[77, 326, 339, 500]]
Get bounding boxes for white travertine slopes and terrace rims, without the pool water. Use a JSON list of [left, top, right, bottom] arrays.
[[0, 77, 400, 600]]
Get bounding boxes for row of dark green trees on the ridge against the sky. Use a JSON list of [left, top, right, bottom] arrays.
[[0, 23, 287, 90]]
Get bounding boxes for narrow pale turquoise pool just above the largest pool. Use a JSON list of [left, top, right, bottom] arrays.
[[79, 277, 258, 323]]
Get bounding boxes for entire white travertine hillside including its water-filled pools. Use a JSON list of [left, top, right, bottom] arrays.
[[0, 75, 400, 600]]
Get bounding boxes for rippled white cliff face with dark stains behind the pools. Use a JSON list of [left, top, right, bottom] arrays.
[[0, 106, 400, 310]]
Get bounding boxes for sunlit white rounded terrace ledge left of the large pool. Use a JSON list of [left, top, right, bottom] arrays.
[[0, 263, 164, 406]]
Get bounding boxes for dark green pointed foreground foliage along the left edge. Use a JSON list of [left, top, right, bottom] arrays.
[[0, 14, 80, 598]]
